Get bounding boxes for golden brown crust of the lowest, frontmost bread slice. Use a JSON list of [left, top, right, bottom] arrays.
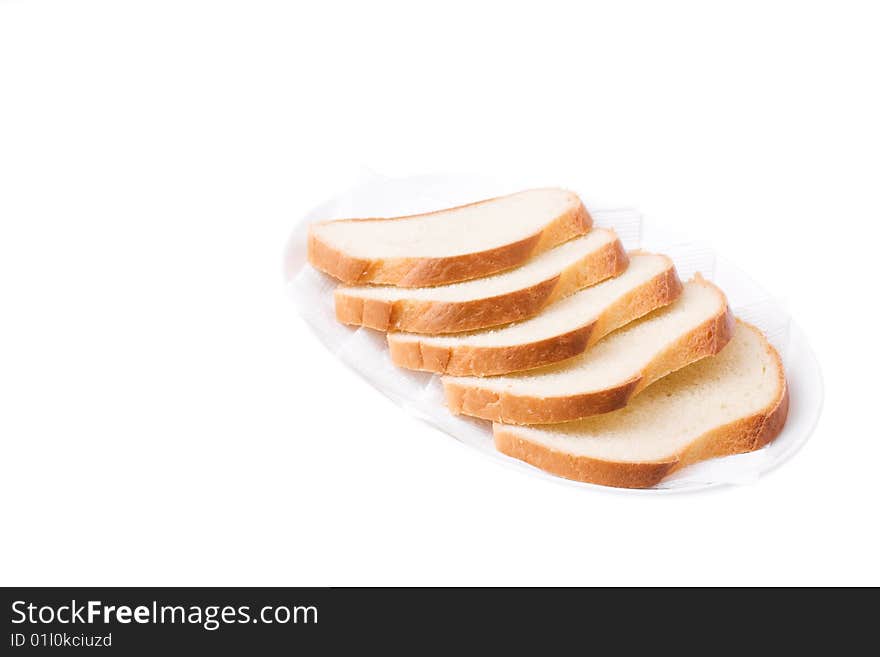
[[493, 322, 789, 488]]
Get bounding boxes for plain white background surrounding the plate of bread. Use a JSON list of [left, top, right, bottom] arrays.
[[0, 0, 880, 585]]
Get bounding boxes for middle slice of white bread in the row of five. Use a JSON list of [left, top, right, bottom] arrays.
[[388, 254, 681, 376]]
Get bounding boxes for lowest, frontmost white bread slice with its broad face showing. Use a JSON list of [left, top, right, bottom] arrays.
[[494, 322, 788, 488]]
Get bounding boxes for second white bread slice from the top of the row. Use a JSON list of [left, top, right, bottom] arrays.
[[335, 228, 629, 333]]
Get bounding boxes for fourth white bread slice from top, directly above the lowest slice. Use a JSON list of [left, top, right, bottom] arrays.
[[443, 275, 734, 424]]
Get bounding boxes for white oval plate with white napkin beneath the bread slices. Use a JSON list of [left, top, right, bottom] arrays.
[[284, 175, 824, 494]]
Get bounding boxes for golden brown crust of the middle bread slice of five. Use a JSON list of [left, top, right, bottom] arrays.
[[388, 261, 682, 376]]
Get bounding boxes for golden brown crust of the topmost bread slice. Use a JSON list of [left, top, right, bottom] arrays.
[[308, 191, 593, 287]]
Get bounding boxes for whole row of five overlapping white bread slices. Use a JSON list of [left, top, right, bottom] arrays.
[[308, 189, 788, 488]]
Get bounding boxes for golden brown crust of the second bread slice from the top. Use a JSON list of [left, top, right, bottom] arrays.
[[335, 234, 629, 334]]
